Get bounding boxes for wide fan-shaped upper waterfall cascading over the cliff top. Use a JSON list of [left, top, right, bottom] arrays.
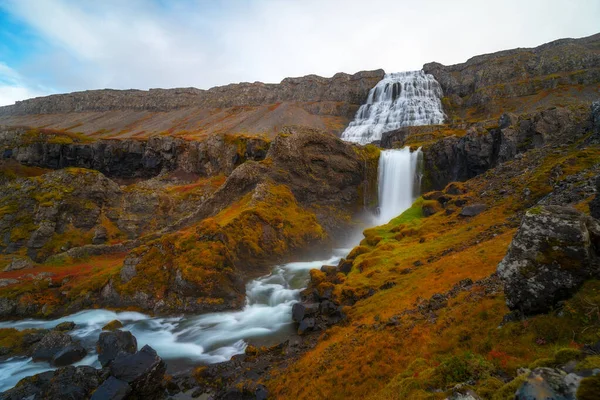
[[341, 70, 445, 144]]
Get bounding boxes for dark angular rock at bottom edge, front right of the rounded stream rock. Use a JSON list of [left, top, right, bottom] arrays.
[[110, 345, 166, 398]]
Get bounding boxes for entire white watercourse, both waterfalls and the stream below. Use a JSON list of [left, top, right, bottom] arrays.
[[0, 71, 434, 392]]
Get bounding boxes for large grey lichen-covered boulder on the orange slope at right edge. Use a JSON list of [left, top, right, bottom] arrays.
[[498, 206, 600, 315]]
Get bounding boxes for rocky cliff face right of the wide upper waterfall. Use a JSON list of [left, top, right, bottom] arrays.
[[423, 34, 600, 119]]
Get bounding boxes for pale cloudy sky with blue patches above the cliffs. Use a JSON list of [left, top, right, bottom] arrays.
[[0, 0, 600, 105]]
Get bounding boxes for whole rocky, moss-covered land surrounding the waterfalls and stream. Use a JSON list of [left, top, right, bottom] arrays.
[[0, 34, 600, 400]]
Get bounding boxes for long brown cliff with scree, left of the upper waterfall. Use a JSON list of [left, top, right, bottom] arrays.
[[0, 70, 384, 138]]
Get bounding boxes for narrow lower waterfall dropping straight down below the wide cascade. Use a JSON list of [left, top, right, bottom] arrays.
[[378, 147, 422, 224]]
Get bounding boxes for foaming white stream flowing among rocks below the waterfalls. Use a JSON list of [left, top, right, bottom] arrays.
[[0, 249, 350, 392]]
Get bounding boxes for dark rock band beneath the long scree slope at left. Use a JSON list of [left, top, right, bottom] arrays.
[[0, 129, 269, 178]]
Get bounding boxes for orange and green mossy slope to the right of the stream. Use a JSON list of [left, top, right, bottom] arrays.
[[267, 140, 600, 399]]
